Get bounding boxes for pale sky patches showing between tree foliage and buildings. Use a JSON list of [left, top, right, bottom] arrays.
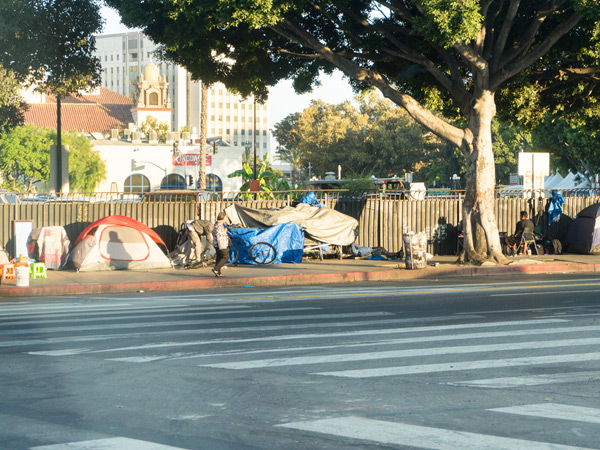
[[101, 7, 354, 132]]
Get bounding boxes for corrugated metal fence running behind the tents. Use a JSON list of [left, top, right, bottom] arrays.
[[0, 190, 600, 256]]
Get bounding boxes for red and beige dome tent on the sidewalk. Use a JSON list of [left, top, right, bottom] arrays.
[[69, 215, 171, 271]]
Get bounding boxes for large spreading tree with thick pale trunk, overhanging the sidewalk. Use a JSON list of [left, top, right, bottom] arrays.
[[107, 0, 600, 260]]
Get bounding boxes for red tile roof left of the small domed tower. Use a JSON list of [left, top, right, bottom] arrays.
[[25, 87, 133, 133]]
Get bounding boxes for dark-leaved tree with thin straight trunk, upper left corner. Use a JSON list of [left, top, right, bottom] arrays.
[[0, 0, 102, 190]]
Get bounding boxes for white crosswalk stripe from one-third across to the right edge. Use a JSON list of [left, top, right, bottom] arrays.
[[199, 338, 600, 370]]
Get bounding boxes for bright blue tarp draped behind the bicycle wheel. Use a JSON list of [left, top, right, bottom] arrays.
[[229, 223, 304, 264]]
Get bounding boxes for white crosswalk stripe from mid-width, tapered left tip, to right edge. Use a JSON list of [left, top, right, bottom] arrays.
[[313, 353, 600, 378]]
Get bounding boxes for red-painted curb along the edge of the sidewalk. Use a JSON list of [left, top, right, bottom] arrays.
[[0, 263, 600, 299]]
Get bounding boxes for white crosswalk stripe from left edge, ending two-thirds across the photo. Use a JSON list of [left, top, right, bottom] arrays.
[[2, 312, 393, 335]]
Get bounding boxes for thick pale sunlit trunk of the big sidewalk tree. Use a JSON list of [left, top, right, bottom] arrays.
[[459, 91, 505, 263]]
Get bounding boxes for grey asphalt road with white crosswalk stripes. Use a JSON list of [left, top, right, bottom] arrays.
[[0, 276, 600, 450]]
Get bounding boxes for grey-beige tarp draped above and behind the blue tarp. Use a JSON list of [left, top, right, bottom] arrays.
[[225, 203, 358, 245]]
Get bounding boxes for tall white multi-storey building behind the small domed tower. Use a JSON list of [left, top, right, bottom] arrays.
[[96, 31, 273, 160]]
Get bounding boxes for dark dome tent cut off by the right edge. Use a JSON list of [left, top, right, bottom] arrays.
[[565, 203, 600, 254]]
